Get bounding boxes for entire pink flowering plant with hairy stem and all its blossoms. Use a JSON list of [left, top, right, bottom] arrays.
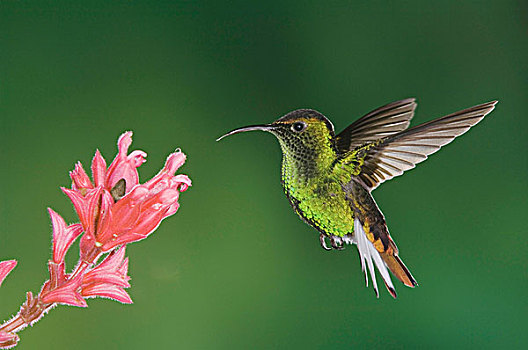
[[0, 132, 191, 349]]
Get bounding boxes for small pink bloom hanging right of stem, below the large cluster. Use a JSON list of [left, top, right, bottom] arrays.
[[81, 245, 132, 304]]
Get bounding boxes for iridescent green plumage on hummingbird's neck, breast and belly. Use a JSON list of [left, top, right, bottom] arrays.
[[276, 117, 354, 237]]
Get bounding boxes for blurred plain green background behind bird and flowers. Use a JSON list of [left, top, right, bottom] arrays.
[[0, 1, 528, 349]]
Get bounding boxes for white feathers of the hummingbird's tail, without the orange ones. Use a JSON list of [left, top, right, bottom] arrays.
[[354, 218, 394, 298]]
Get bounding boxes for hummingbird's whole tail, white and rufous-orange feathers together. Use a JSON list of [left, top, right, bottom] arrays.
[[354, 217, 418, 298]]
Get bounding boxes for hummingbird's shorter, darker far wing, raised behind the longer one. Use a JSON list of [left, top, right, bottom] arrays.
[[336, 98, 416, 153]]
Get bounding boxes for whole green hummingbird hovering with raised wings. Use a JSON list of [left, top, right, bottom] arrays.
[[217, 98, 498, 298]]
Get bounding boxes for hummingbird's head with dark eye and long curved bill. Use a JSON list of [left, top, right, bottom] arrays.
[[217, 109, 335, 158]]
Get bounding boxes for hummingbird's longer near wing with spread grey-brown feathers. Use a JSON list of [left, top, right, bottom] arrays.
[[336, 101, 497, 190]]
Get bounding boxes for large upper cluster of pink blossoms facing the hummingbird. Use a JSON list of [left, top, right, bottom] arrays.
[[62, 132, 191, 259]]
